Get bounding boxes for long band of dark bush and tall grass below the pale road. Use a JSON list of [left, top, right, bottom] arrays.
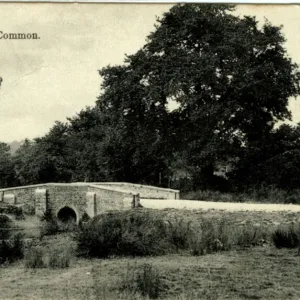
[[76, 211, 269, 258]]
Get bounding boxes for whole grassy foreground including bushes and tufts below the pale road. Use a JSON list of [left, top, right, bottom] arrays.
[[0, 209, 300, 300]]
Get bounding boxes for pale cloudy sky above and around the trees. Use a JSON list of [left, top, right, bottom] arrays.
[[0, 3, 300, 143]]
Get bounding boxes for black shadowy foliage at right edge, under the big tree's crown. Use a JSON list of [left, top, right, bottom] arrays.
[[230, 124, 300, 191]]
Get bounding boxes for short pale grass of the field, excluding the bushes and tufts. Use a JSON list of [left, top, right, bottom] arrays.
[[0, 210, 300, 300]]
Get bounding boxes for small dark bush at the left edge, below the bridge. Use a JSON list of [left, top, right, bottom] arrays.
[[0, 234, 24, 264]]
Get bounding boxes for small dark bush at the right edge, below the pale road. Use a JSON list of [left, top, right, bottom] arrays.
[[272, 224, 300, 248]]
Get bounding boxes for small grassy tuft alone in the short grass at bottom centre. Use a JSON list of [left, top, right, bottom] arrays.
[[121, 264, 166, 299]]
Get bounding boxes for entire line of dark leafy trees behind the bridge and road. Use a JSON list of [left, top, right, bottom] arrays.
[[0, 4, 300, 191]]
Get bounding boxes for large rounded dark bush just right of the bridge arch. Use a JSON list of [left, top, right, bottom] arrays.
[[76, 210, 174, 257]]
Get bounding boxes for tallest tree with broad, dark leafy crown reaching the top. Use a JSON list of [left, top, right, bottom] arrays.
[[101, 4, 300, 188]]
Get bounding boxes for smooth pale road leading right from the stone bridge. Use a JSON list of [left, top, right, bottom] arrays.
[[141, 199, 300, 212]]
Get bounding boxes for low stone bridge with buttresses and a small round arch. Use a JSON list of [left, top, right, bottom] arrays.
[[0, 182, 179, 222]]
